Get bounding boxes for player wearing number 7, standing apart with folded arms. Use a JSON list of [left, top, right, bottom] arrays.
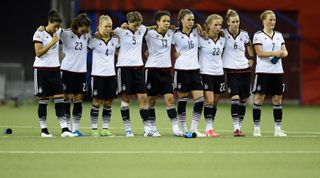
[[252, 10, 288, 137]]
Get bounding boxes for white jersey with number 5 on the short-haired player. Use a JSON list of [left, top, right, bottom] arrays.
[[114, 25, 147, 67]]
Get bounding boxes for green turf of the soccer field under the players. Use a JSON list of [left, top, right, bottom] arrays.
[[0, 101, 320, 178]]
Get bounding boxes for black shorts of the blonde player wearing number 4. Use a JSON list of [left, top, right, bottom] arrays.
[[91, 76, 117, 100]]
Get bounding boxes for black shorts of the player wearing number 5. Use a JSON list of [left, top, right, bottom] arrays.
[[117, 67, 147, 95]]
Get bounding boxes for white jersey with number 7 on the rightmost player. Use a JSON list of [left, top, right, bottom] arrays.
[[253, 31, 284, 74]]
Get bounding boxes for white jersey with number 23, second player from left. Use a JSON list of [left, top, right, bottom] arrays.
[[60, 29, 90, 73]]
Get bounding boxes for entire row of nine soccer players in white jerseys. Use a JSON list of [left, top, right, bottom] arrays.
[[33, 9, 288, 137]]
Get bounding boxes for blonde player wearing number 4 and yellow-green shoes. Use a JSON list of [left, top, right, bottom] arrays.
[[89, 15, 119, 137]]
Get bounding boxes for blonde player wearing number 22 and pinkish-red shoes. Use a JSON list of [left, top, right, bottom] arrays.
[[199, 14, 225, 137]]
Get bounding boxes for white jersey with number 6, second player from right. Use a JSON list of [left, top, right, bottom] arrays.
[[222, 29, 250, 69]]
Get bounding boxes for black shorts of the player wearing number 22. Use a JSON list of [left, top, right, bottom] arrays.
[[201, 74, 226, 94]]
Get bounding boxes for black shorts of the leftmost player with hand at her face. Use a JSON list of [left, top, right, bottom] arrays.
[[34, 68, 63, 97]]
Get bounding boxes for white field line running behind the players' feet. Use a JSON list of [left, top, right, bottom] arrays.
[[0, 125, 320, 135]]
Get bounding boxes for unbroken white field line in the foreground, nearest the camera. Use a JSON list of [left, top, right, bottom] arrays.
[[0, 150, 320, 154]]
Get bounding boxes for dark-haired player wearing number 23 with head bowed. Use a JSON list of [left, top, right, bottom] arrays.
[[60, 14, 91, 136]]
